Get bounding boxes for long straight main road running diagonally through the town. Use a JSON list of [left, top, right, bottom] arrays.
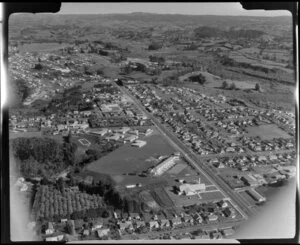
[[113, 83, 255, 219]]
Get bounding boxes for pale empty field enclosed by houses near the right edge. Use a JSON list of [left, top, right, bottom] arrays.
[[247, 124, 290, 140]]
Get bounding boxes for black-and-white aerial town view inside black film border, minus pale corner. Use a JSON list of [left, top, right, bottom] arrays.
[[7, 2, 297, 243]]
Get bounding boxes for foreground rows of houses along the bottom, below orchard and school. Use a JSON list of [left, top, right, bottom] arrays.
[[37, 203, 236, 241]]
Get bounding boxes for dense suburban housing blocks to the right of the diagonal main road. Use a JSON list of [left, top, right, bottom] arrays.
[[124, 83, 294, 161]]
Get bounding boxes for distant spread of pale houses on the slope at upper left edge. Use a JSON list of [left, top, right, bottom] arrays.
[[9, 52, 100, 104]]
